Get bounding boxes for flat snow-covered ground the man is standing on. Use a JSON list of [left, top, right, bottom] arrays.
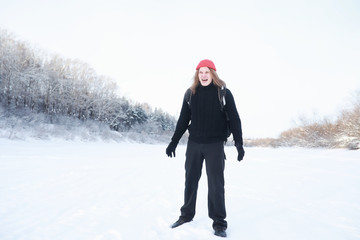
[[0, 139, 360, 240]]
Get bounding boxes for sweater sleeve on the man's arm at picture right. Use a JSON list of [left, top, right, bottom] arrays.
[[225, 89, 243, 145]]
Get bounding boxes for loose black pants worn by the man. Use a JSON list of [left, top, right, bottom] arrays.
[[181, 140, 227, 229]]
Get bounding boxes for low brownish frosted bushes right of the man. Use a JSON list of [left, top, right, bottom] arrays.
[[246, 91, 360, 149]]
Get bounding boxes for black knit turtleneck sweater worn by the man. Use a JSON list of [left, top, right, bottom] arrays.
[[171, 83, 243, 145]]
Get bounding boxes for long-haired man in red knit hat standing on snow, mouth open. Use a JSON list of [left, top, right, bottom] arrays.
[[166, 59, 245, 237]]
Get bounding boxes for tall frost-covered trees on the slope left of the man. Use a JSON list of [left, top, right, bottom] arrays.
[[0, 29, 176, 139]]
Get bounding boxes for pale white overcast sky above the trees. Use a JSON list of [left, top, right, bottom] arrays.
[[0, 0, 360, 137]]
